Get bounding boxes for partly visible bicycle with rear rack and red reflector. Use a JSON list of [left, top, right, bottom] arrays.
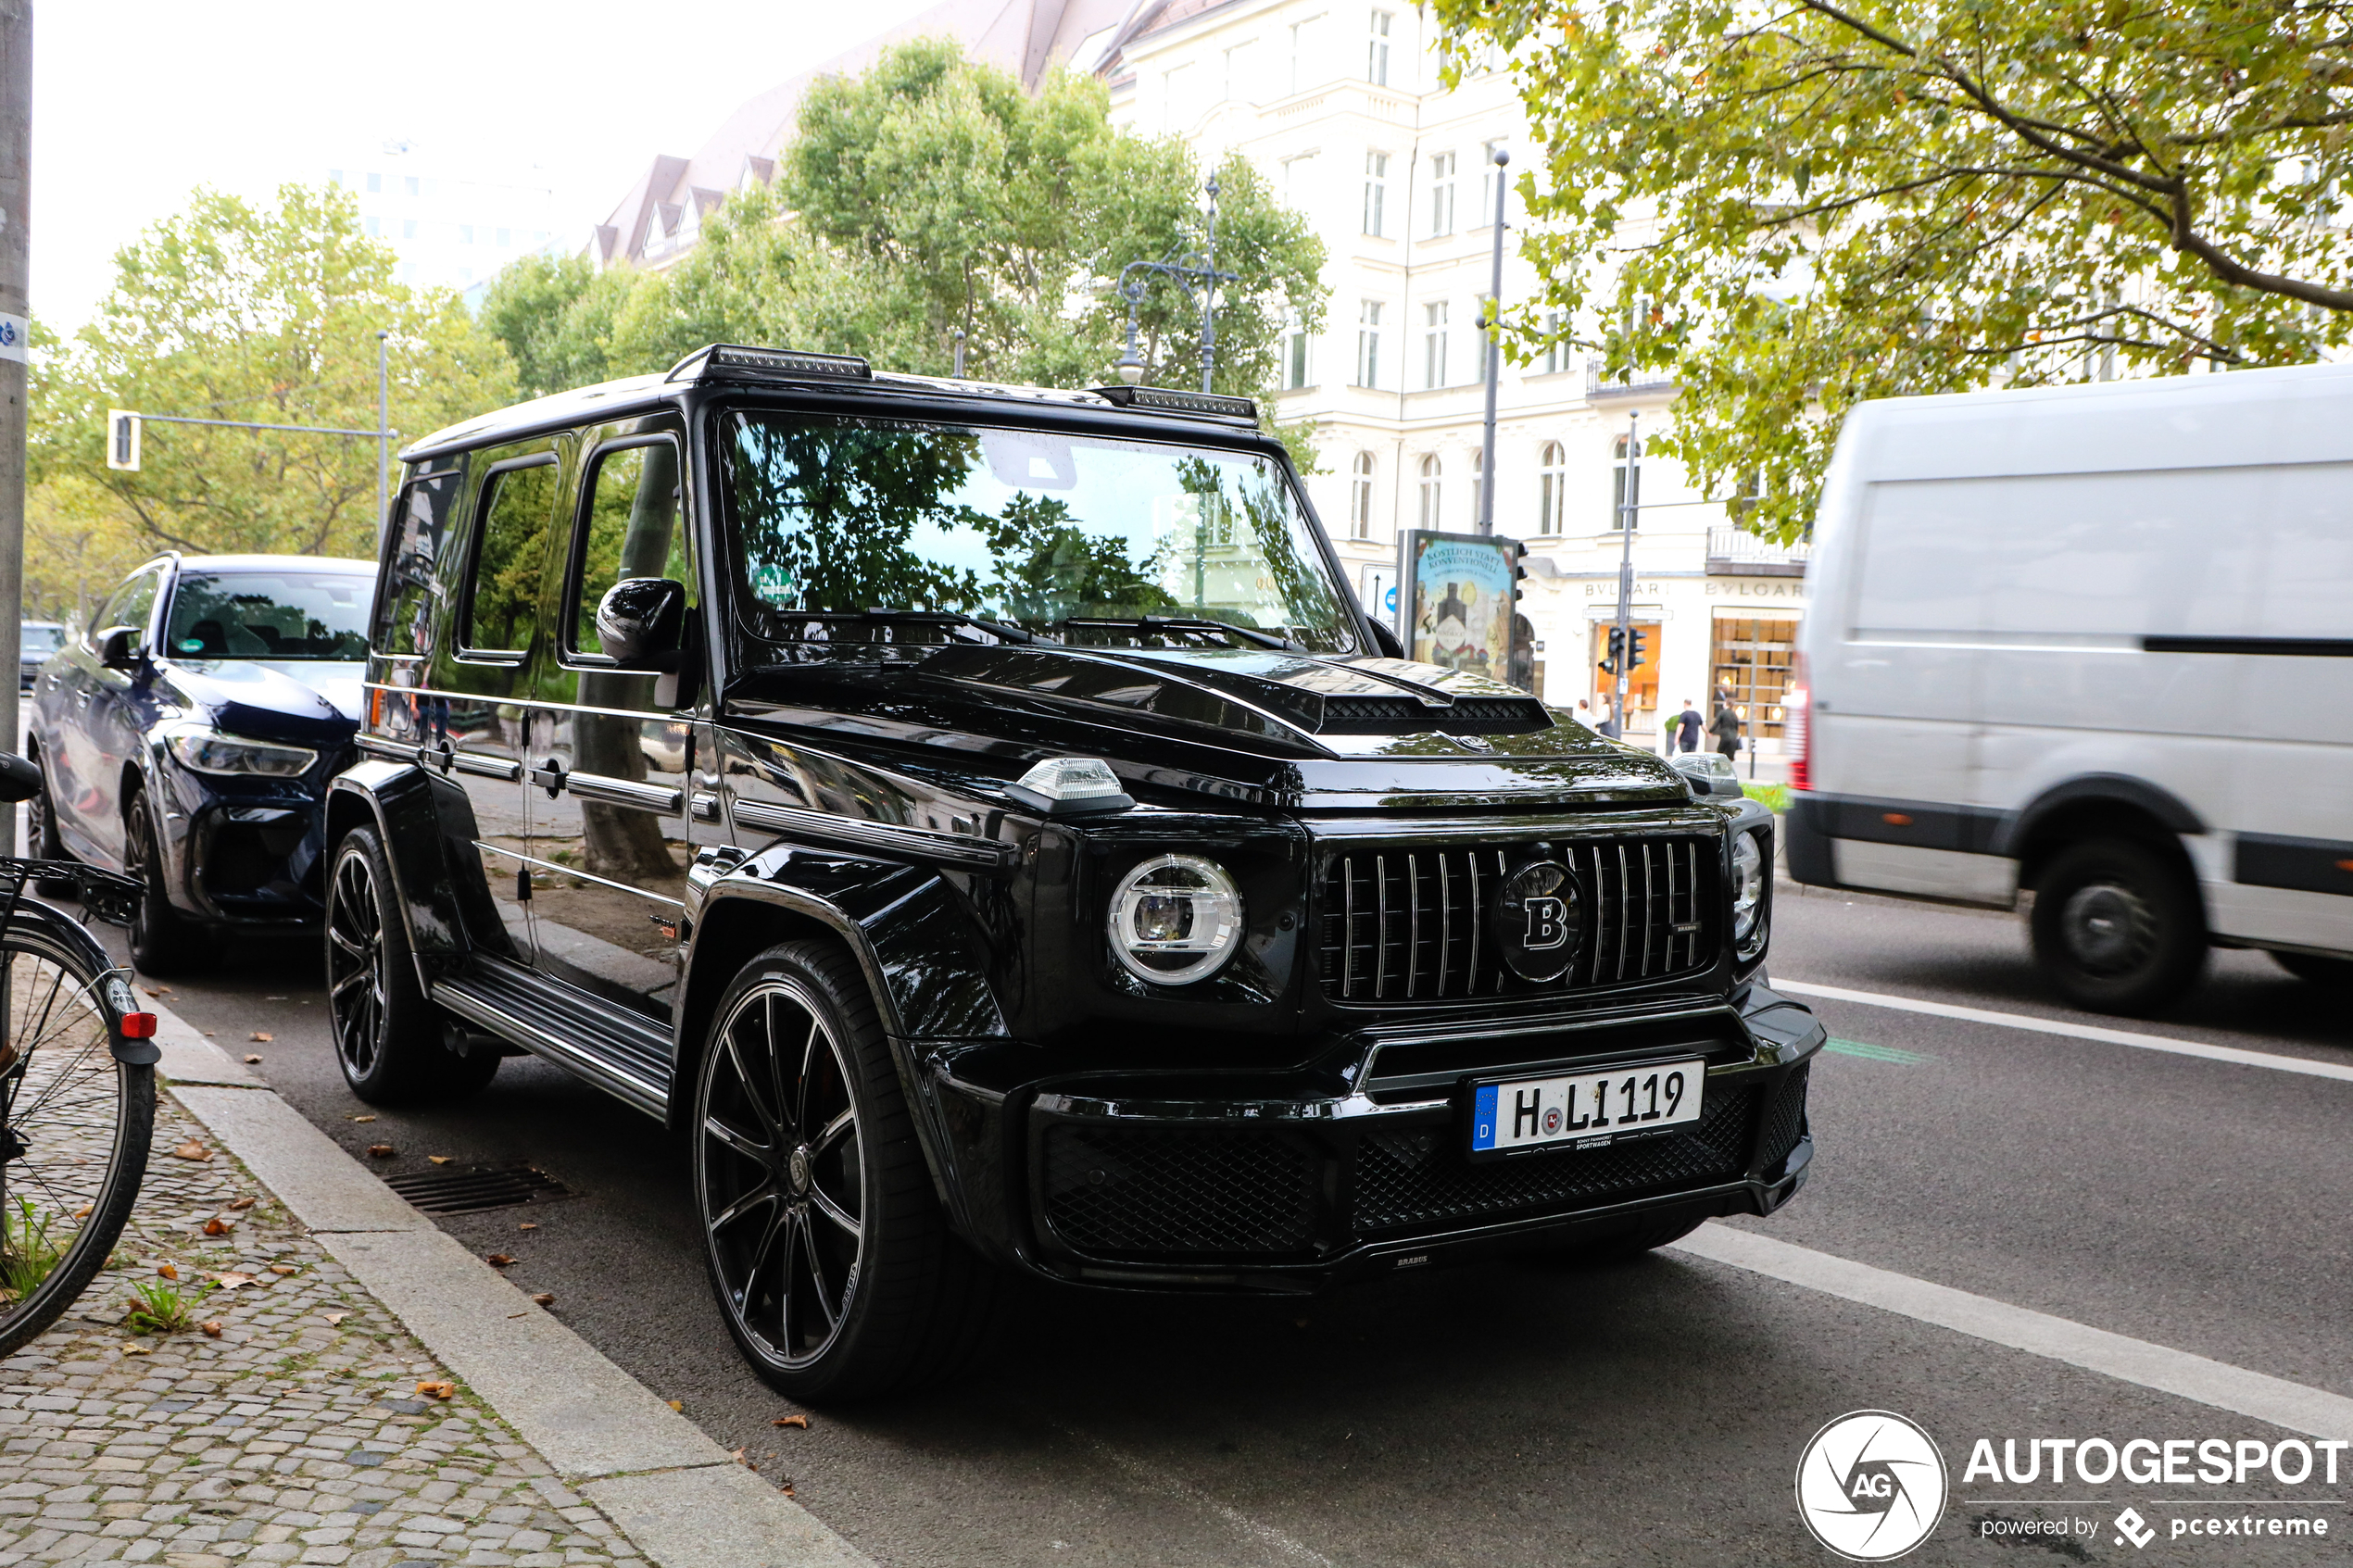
[[0, 752, 160, 1357]]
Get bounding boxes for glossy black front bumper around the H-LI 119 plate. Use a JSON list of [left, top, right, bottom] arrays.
[[932, 985, 1824, 1293]]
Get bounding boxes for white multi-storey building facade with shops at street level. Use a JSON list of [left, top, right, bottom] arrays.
[[1097, 0, 1805, 759]]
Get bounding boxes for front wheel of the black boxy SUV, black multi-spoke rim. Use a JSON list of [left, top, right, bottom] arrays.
[[689, 943, 1000, 1403]]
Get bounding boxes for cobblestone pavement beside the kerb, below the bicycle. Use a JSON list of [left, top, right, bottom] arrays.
[[0, 1098, 640, 1568]]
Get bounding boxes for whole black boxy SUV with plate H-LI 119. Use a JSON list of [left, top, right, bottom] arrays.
[[327, 345, 1824, 1399]]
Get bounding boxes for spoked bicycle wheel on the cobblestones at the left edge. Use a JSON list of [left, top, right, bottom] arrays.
[[0, 924, 156, 1357]]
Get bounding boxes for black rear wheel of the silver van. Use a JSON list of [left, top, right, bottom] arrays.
[[2033, 839, 2208, 1016]]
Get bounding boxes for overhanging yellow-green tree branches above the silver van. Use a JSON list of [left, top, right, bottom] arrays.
[[1438, 0, 2353, 536]]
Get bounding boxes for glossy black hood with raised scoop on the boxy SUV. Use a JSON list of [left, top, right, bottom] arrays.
[[727, 644, 1690, 807]]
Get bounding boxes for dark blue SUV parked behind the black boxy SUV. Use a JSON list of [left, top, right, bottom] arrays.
[[26, 555, 376, 973]]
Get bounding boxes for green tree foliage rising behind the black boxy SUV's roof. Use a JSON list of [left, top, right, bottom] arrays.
[[483, 40, 1325, 411]]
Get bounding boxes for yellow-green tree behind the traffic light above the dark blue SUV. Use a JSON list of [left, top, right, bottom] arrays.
[[28, 186, 515, 555]]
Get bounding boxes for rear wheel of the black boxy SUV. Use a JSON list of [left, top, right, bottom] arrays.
[[327, 827, 498, 1105]]
